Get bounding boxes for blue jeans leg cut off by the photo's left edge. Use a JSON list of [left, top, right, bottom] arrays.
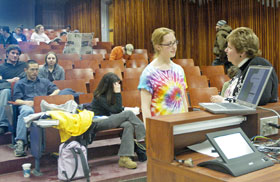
[[0, 89, 11, 127]]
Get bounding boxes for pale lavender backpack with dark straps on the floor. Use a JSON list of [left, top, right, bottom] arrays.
[[57, 141, 90, 182]]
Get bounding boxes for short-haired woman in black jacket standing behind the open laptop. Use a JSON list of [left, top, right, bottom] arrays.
[[211, 27, 278, 105]]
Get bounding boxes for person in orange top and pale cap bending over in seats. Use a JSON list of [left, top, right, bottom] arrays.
[[109, 44, 134, 63]]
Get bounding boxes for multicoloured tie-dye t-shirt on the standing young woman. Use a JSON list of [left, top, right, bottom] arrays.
[[138, 62, 187, 116]]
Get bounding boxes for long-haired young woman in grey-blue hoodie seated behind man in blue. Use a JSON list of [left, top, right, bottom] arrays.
[[38, 52, 65, 82]]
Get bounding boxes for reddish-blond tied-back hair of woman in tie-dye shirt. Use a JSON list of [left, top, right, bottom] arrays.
[[152, 27, 175, 58]]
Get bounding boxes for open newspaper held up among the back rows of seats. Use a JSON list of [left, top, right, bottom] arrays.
[[63, 33, 94, 54]]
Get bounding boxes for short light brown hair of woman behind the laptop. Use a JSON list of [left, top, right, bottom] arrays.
[[227, 27, 261, 58]]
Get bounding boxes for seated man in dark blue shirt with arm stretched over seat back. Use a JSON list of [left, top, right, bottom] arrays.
[[13, 60, 59, 157]]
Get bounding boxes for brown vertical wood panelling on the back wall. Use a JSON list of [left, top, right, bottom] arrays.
[[66, 0, 280, 79]]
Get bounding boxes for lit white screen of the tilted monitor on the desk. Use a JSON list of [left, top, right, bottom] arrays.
[[214, 133, 254, 159]]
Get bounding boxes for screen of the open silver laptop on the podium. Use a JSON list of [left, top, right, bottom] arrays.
[[237, 66, 272, 105]]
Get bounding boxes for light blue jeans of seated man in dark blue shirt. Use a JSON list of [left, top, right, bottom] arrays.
[[15, 105, 34, 144]]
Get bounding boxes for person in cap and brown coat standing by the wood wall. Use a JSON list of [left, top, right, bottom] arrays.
[[212, 20, 232, 72]]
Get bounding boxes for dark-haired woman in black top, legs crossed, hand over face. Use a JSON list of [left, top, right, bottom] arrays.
[[92, 73, 146, 169]]
